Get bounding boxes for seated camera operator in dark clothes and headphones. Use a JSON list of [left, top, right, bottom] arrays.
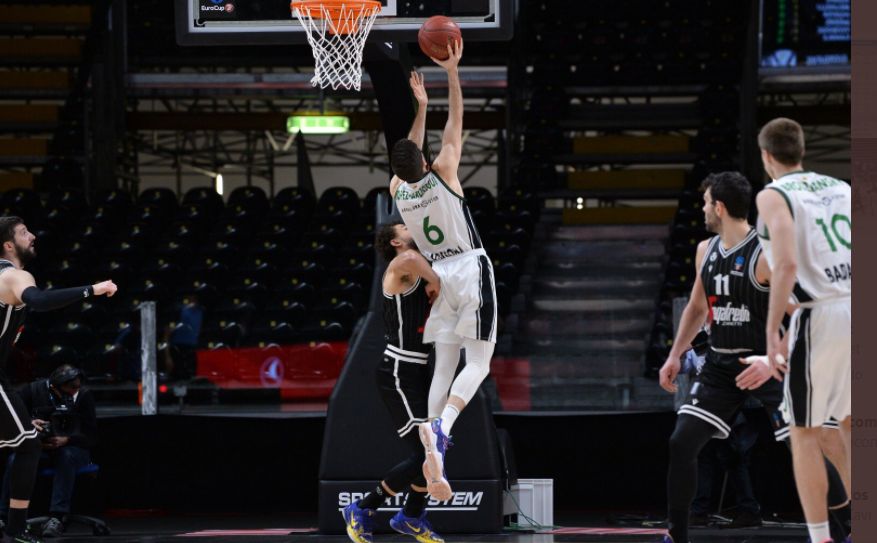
[[0, 364, 97, 537]]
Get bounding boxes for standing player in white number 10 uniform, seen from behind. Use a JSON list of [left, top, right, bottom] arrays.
[[756, 118, 852, 543]]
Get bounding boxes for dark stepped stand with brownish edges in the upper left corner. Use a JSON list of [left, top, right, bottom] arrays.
[[0, 1, 92, 190]]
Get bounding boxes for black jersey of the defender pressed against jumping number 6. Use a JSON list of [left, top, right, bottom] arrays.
[[384, 278, 431, 353]]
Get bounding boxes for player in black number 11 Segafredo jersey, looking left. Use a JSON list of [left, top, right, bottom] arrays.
[[660, 172, 846, 543]]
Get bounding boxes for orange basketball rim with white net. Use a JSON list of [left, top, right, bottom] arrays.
[[290, 0, 381, 90]]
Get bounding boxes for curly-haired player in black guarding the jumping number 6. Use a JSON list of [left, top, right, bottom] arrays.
[[344, 222, 447, 543]]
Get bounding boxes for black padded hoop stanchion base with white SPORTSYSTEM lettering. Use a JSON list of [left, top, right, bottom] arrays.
[[319, 195, 503, 533]]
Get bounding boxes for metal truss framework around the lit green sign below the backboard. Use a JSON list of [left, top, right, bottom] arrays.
[[125, 97, 504, 194]]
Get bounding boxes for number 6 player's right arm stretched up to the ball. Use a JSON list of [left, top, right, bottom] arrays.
[[432, 41, 463, 195]]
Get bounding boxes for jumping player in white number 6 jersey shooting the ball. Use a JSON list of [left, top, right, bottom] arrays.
[[390, 42, 497, 499]]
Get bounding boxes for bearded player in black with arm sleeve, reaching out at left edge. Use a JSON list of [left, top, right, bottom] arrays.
[[0, 217, 116, 543]]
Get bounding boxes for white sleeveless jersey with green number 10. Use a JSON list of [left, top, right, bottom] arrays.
[[757, 172, 853, 304]]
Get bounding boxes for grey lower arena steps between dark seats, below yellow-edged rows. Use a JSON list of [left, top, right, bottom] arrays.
[[500, 209, 670, 410]]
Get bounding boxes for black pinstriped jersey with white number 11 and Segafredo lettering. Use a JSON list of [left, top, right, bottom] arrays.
[[700, 229, 770, 354]]
